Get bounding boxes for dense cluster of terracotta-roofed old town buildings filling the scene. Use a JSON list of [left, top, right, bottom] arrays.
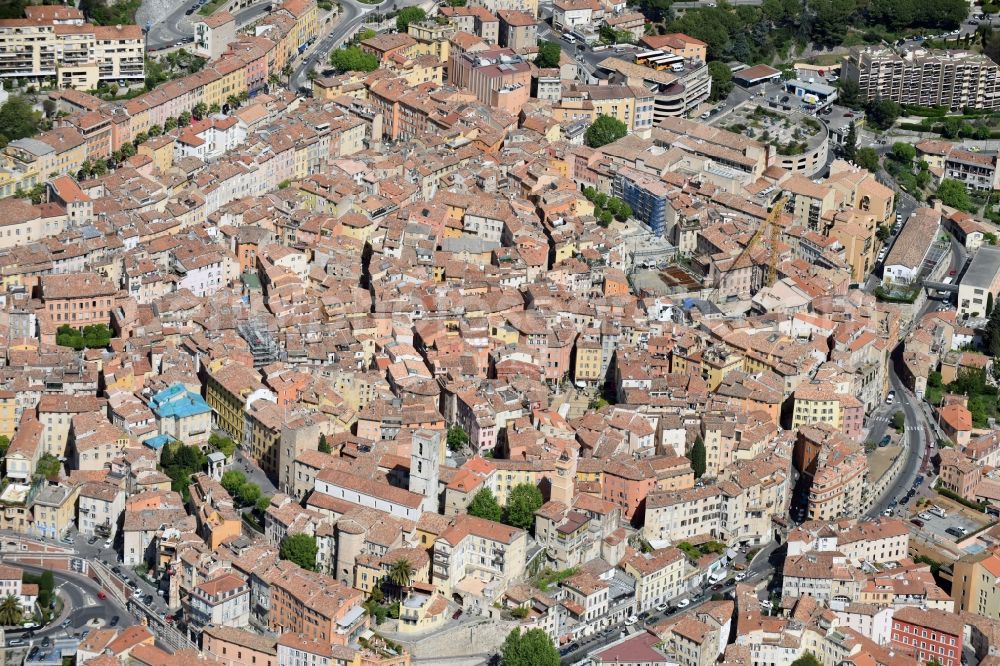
[[0, 0, 1000, 666]]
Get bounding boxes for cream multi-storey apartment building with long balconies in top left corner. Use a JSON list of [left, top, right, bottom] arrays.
[[0, 5, 146, 90]]
